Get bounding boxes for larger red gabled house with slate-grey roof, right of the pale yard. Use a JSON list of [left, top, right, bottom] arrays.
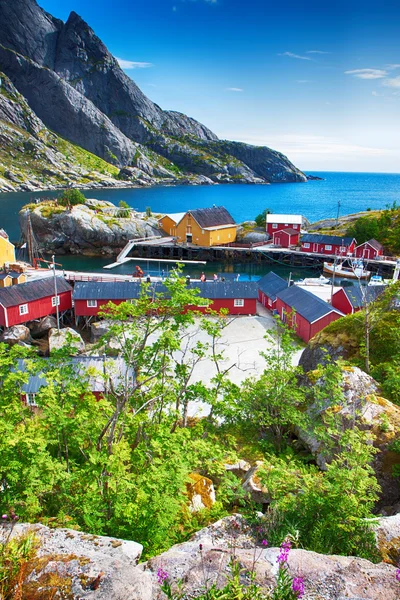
[[276, 285, 343, 342]]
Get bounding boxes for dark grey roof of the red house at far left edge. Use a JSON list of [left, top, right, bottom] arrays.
[[0, 277, 72, 308]]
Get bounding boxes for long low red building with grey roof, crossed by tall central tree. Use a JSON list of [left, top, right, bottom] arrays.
[[73, 281, 258, 317]]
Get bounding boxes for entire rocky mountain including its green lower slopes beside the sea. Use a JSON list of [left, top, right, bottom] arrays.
[[0, 0, 307, 192]]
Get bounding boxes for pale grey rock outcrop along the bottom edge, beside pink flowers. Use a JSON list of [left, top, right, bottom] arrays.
[[0, 515, 399, 600]]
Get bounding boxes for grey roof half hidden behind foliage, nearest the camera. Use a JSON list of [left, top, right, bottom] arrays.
[[15, 356, 133, 394]]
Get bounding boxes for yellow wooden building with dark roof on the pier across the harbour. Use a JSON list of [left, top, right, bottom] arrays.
[[159, 206, 236, 247]]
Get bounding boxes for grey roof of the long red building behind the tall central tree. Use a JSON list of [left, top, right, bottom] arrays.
[[73, 281, 258, 300]]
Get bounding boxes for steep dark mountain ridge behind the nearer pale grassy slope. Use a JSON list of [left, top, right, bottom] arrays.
[[0, 0, 306, 191]]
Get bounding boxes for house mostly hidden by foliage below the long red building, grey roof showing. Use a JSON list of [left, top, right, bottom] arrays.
[[16, 356, 134, 407]]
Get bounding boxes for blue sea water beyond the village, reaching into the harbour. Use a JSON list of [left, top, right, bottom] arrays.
[[0, 172, 400, 276]]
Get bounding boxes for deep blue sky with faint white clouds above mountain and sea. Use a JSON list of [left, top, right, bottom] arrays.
[[39, 0, 400, 172]]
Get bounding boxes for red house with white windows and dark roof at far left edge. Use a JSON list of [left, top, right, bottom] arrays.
[[0, 277, 72, 327]]
